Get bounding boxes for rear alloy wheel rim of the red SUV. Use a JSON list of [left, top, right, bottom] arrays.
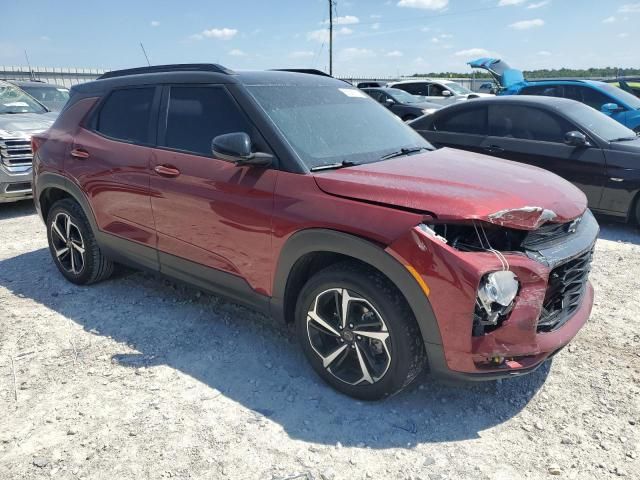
[[51, 212, 85, 275]]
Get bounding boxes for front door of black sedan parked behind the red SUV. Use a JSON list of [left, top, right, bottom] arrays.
[[482, 104, 606, 209]]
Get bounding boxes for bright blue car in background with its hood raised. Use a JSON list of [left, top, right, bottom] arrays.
[[468, 58, 640, 133]]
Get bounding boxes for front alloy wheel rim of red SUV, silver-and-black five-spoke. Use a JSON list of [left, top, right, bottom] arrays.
[[307, 288, 391, 385]]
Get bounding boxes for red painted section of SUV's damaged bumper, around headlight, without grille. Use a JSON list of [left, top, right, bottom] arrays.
[[387, 228, 593, 373]]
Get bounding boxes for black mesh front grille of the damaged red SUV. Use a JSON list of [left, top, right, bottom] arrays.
[[538, 249, 593, 332]]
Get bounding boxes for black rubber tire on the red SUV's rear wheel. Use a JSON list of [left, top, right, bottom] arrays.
[[47, 198, 113, 285]]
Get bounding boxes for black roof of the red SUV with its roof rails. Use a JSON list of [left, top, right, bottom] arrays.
[[72, 63, 344, 94]]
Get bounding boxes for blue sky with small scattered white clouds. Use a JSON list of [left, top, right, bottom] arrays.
[[0, 0, 640, 76]]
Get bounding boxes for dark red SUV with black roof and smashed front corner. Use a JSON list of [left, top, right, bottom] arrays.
[[33, 64, 598, 399]]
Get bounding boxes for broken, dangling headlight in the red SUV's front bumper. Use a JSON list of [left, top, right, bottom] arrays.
[[473, 270, 520, 336]]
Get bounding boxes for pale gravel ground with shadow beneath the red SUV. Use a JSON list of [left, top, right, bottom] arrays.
[[0, 203, 640, 480]]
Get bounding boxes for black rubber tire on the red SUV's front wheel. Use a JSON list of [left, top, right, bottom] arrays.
[[295, 262, 427, 400]]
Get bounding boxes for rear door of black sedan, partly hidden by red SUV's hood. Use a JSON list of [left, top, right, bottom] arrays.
[[411, 102, 488, 153]]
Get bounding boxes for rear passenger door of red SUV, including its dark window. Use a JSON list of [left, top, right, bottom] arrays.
[[65, 86, 160, 267]]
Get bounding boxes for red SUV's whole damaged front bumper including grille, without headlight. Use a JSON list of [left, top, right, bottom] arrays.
[[388, 210, 599, 380]]
